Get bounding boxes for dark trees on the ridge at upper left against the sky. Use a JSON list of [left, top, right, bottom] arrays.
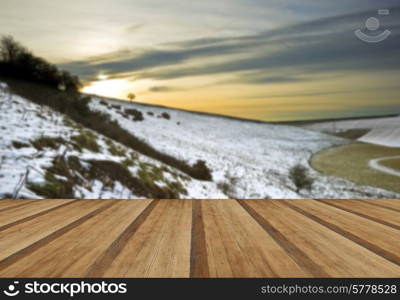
[[0, 36, 82, 92]]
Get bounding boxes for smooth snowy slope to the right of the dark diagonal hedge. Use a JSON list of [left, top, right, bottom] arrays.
[[90, 97, 395, 198]]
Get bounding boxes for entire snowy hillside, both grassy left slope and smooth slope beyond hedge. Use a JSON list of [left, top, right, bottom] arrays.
[[0, 84, 399, 199]]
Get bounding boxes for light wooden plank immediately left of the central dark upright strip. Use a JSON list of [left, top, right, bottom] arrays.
[[104, 200, 192, 277]]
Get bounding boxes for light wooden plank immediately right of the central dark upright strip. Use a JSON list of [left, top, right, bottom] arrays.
[[202, 200, 311, 277]]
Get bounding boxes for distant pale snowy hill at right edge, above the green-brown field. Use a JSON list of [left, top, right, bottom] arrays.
[[302, 116, 400, 147]]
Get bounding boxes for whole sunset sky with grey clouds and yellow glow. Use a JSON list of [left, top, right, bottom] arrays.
[[0, 0, 400, 121]]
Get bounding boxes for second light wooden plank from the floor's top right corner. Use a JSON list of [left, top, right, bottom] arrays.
[[318, 200, 400, 230]]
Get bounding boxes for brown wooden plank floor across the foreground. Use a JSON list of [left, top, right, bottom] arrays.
[[0, 200, 400, 277]]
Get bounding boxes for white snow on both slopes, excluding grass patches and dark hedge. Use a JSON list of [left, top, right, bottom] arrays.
[[0, 78, 400, 199]]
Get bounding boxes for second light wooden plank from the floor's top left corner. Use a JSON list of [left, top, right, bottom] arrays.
[[0, 199, 74, 230]]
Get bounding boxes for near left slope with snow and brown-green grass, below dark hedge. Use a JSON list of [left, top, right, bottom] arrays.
[[0, 84, 224, 198]]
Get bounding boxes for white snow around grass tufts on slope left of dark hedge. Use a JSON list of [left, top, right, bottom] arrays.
[[0, 83, 224, 198]]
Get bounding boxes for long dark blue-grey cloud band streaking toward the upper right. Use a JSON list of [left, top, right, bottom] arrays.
[[62, 6, 400, 84]]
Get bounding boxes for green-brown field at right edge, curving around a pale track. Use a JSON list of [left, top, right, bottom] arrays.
[[311, 143, 400, 192]]
